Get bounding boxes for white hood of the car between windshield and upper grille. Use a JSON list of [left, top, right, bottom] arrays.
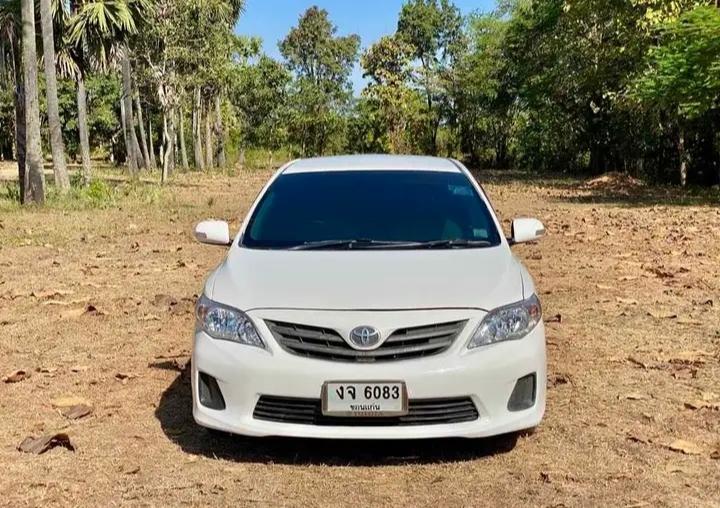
[[205, 246, 523, 310]]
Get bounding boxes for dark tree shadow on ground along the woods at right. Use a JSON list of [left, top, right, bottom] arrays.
[[473, 170, 720, 207]]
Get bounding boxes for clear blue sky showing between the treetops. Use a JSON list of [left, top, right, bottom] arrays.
[[236, 0, 495, 93]]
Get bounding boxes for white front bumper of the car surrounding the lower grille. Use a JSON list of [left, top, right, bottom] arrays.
[[191, 312, 546, 439]]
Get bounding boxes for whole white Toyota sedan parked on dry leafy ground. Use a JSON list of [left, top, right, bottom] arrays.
[[192, 155, 546, 439]]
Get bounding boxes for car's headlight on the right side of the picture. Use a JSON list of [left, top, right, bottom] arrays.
[[468, 295, 542, 349]]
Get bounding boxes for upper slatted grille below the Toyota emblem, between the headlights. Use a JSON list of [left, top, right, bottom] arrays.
[[265, 320, 467, 362]]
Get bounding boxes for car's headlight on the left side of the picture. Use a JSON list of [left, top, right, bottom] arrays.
[[195, 295, 266, 349]]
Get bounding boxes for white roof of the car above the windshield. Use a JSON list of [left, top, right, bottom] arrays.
[[283, 155, 461, 174]]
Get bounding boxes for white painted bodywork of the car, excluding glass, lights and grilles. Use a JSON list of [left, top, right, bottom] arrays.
[[191, 156, 546, 439]]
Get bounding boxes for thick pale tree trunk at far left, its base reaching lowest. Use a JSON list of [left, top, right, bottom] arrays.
[[21, 0, 45, 203]]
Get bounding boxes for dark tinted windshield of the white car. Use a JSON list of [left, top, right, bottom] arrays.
[[242, 171, 500, 249]]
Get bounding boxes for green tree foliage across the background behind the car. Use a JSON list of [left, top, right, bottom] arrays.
[[0, 0, 720, 189]]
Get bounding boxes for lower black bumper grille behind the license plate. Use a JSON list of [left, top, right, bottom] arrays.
[[253, 395, 478, 427]]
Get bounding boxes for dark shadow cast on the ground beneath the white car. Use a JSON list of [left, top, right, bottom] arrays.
[[151, 362, 518, 466]]
